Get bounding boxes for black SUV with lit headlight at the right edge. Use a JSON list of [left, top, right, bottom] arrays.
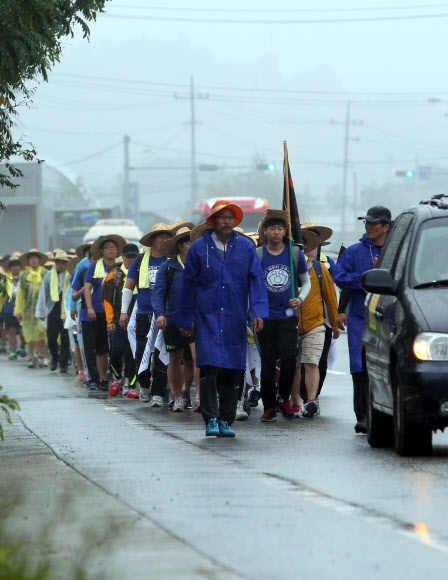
[[362, 195, 448, 455]]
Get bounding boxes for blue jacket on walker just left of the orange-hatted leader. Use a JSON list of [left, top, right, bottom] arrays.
[[151, 257, 184, 324]]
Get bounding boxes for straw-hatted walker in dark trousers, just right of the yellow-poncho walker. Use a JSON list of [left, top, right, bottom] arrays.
[[36, 250, 70, 373]]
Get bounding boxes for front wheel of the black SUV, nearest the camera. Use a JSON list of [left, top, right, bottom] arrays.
[[394, 375, 432, 455]]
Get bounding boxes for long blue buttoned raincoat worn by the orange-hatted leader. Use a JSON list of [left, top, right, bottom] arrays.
[[177, 230, 269, 370]]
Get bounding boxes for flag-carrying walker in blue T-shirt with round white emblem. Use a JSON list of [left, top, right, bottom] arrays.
[[257, 209, 310, 422]]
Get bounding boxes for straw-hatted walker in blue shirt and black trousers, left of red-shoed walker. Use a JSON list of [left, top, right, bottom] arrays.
[[72, 234, 126, 391]]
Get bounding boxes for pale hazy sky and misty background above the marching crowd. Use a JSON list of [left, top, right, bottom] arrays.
[[11, 0, 448, 239]]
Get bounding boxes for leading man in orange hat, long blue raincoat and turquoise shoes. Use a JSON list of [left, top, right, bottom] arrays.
[[177, 200, 269, 437]]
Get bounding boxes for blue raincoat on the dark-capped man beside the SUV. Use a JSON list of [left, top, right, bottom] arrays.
[[333, 234, 381, 373]]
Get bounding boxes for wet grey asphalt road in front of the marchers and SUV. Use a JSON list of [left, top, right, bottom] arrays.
[[0, 336, 448, 579]]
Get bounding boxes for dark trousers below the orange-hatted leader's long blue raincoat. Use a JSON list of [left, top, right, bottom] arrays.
[[200, 365, 244, 425]]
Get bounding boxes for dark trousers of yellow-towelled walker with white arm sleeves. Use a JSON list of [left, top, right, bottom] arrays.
[[135, 313, 167, 397]]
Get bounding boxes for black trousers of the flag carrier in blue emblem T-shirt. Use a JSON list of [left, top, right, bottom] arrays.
[[258, 316, 299, 409]]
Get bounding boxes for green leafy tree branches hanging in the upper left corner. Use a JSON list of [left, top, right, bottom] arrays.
[[0, 0, 107, 188]]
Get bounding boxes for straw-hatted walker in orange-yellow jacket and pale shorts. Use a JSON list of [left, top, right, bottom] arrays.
[[291, 228, 340, 419]]
